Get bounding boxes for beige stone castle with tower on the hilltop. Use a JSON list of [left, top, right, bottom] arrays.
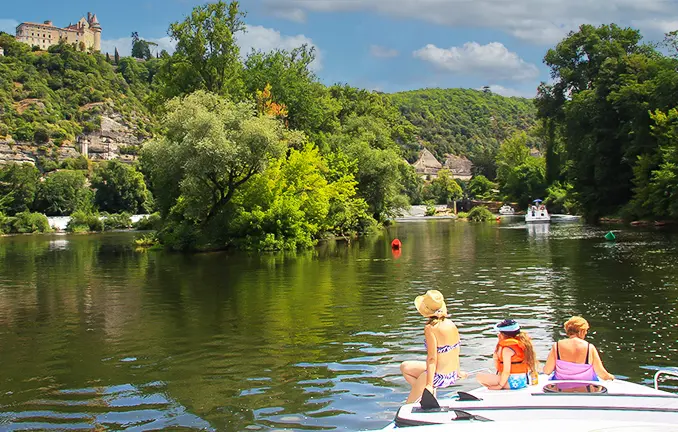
[[16, 12, 101, 51]]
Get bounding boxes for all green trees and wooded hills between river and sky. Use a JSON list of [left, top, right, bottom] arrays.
[[0, 1, 678, 251]]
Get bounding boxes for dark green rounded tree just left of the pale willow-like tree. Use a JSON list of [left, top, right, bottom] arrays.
[[92, 160, 152, 214]]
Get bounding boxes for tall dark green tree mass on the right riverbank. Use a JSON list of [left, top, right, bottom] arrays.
[[536, 24, 678, 219]]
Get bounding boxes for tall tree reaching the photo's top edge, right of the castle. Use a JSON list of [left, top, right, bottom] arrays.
[[162, 0, 247, 96]]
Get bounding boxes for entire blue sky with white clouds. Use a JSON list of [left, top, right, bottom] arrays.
[[0, 0, 678, 97]]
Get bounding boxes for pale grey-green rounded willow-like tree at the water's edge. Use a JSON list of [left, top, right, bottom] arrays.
[[141, 91, 285, 224]]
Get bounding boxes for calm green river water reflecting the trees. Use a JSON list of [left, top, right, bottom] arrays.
[[0, 219, 678, 431]]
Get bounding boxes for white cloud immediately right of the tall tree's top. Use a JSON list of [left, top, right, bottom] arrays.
[[237, 26, 322, 71]]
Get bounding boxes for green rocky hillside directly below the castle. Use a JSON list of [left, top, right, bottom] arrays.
[[0, 33, 150, 145]]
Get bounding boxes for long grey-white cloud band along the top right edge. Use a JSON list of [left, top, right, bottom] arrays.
[[264, 0, 678, 45]]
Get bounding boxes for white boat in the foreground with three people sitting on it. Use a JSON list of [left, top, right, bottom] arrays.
[[374, 371, 678, 432]]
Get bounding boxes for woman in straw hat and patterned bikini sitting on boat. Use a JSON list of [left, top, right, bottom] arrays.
[[400, 290, 460, 403]]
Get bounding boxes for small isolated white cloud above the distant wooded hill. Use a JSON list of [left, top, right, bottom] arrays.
[[413, 42, 539, 81]]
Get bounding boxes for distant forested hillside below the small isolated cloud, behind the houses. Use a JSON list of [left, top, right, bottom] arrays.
[[389, 88, 536, 160]]
